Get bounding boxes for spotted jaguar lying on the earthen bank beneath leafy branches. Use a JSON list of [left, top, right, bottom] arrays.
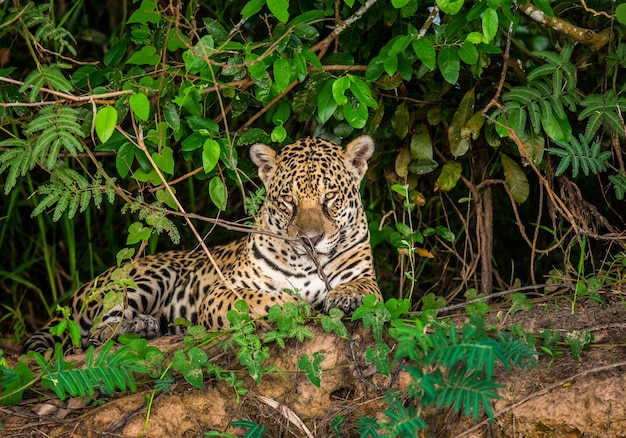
[[24, 135, 382, 353]]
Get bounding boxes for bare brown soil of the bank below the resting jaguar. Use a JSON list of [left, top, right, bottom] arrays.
[[0, 291, 626, 438]]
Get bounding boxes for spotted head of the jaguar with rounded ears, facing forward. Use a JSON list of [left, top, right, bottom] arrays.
[[250, 135, 374, 257]]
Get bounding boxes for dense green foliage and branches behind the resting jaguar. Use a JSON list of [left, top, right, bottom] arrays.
[[0, 0, 626, 434]]
